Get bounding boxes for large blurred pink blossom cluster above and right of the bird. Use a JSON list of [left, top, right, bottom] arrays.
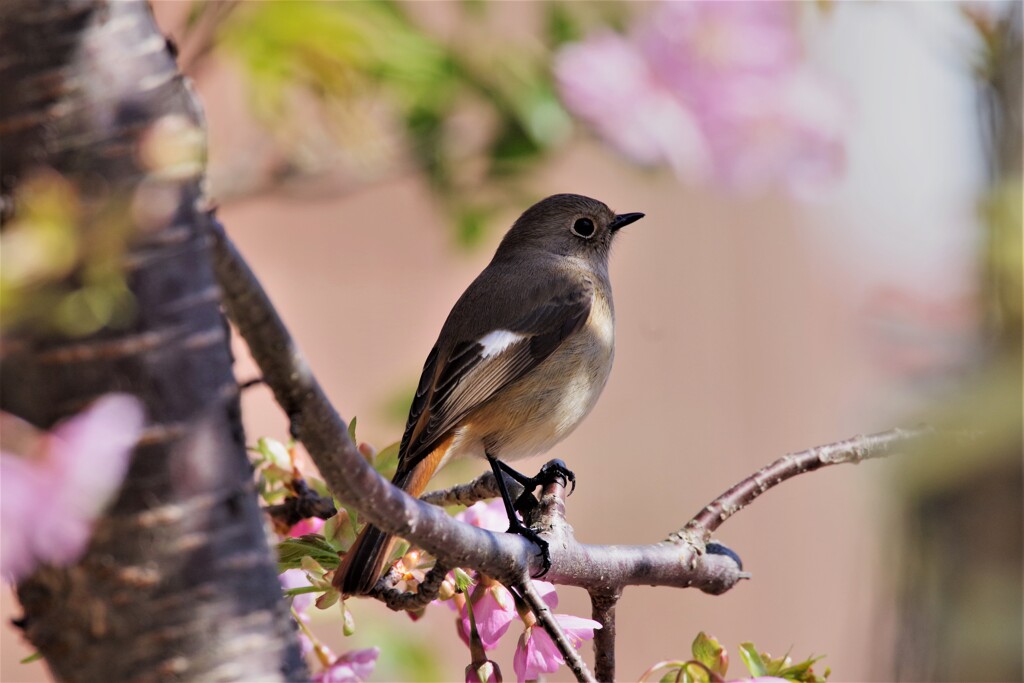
[[554, 2, 846, 197]]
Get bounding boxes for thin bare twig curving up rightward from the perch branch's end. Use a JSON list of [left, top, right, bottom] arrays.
[[669, 426, 935, 543]]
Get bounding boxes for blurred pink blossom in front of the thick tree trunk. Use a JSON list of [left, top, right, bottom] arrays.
[[0, 394, 144, 581]]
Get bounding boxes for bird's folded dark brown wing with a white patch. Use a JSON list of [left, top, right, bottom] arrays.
[[396, 272, 594, 478]]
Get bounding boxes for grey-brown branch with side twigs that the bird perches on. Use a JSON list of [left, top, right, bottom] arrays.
[[209, 222, 930, 681]]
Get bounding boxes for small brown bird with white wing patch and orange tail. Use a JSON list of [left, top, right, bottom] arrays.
[[335, 195, 644, 595]]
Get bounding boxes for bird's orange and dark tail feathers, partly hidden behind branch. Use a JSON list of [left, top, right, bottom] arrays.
[[334, 437, 453, 596]]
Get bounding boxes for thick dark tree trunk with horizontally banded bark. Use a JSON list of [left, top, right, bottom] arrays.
[[0, 0, 306, 681]]
